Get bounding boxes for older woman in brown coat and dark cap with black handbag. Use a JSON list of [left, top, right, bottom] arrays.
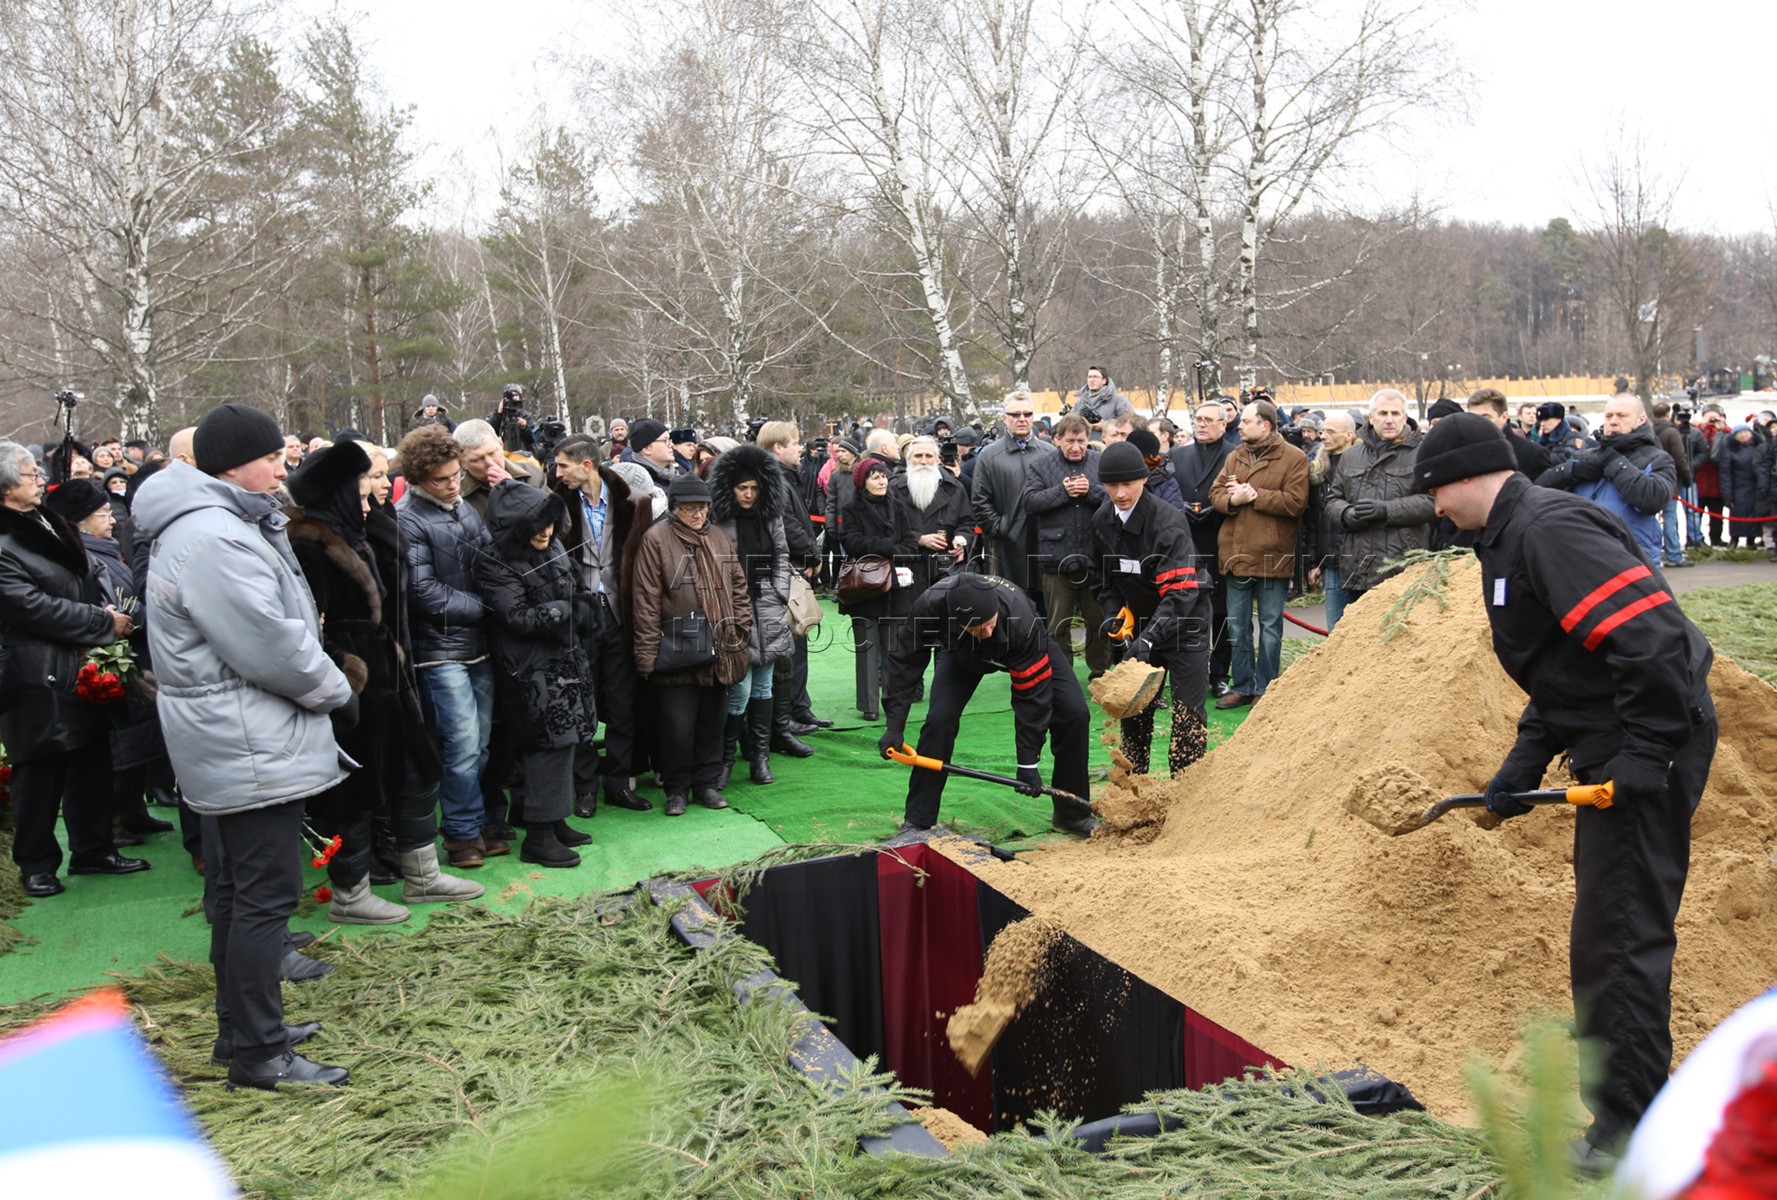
[[629, 475, 753, 816]]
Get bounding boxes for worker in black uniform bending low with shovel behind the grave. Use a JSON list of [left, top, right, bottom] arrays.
[[876, 574, 1098, 837]]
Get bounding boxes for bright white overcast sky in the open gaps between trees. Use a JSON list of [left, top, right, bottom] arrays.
[[305, 0, 1777, 233]]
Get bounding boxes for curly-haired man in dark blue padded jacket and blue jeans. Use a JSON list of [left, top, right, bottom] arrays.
[[394, 425, 510, 868]]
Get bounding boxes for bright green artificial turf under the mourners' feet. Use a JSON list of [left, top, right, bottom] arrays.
[[0, 597, 1247, 1004]]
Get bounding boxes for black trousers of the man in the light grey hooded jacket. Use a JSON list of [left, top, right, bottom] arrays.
[[204, 800, 304, 1063]]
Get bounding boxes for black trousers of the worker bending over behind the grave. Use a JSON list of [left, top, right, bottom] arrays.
[[906, 638, 1093, 828]]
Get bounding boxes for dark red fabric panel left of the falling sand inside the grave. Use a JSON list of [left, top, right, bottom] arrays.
[[876, 844, 993, 1129]]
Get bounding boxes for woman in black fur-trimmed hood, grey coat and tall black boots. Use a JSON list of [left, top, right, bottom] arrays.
[[709, 444, 796, 788]]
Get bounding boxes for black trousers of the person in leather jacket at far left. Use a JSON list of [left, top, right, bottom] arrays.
[[12, 731, 117, 875]]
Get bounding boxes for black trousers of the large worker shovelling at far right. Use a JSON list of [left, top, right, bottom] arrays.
[[1567, 697, 1718, 1148]]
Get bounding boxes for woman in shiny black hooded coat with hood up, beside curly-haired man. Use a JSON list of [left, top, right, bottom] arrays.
[[474, 480, 594, 868]]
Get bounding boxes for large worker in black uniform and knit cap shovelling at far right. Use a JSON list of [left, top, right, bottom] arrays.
[[1413, 412, 1717, 1173]]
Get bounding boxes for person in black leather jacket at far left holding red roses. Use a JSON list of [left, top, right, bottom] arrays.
[[0, 441, 147, 896]]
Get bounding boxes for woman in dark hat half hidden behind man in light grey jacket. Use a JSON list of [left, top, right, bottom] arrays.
[[44, 480, 172, 846]]
